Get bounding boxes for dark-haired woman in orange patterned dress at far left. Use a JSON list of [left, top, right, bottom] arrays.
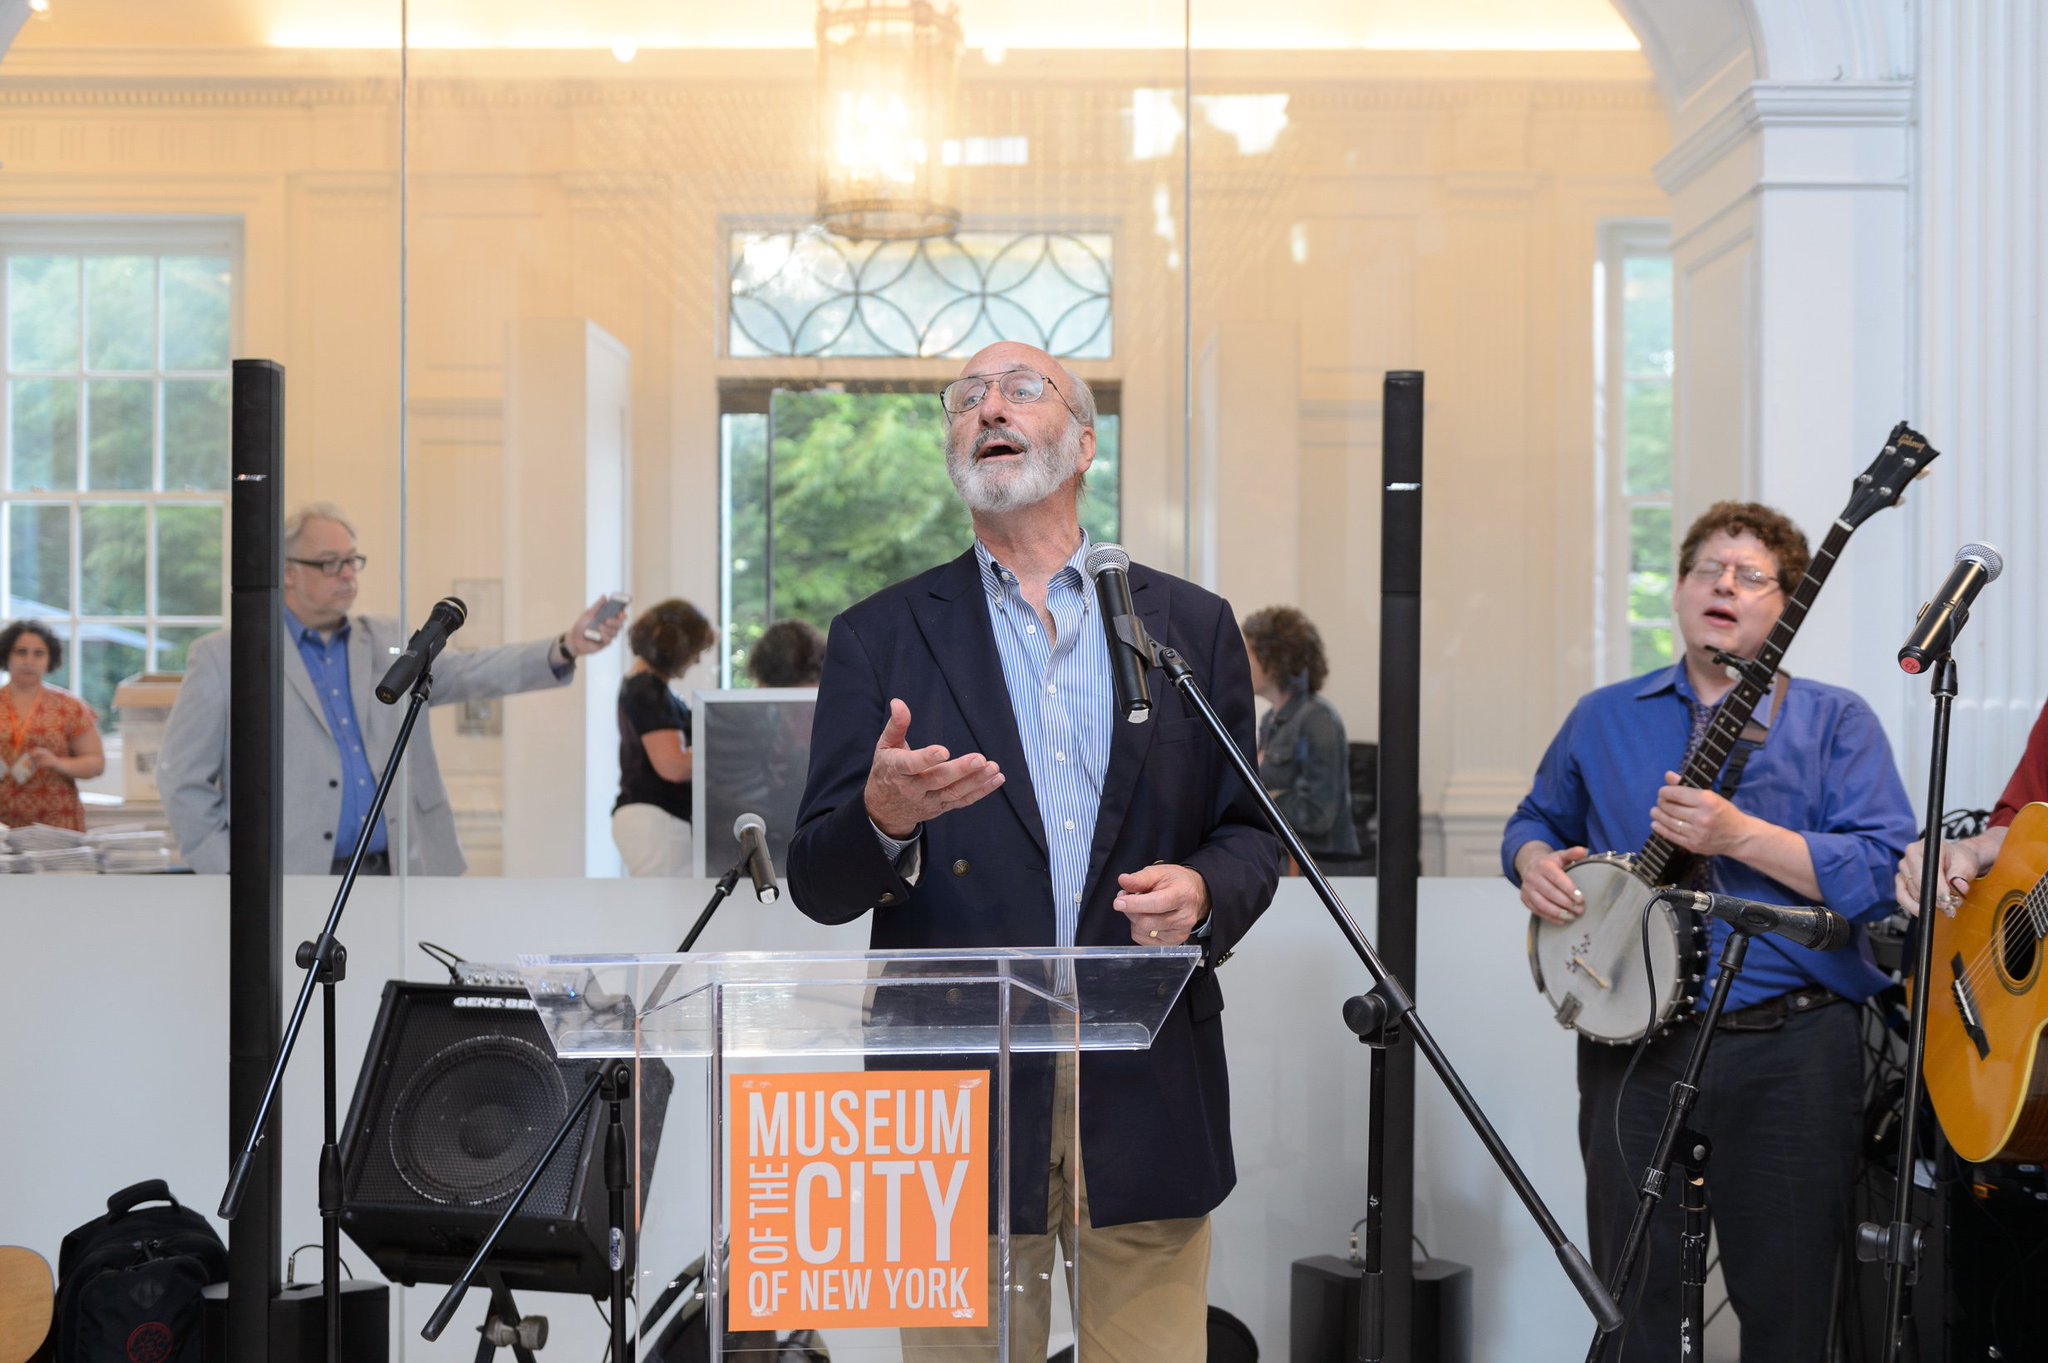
[[0, 620, 106, 833]]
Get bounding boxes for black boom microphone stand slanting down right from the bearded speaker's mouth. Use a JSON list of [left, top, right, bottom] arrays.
[[1116, 634, 1622, 1334]]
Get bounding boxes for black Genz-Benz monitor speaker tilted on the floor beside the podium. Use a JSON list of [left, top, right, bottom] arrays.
[[342, 980, 674, 1298]]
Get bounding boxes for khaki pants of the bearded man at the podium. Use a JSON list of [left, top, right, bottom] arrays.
[[903, 1056, 1208, 1363]]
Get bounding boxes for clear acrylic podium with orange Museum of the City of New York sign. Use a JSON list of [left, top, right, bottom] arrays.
[[520, 946, 1200, 1363]]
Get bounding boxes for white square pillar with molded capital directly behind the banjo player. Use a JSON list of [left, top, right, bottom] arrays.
[[1657, 82, 1948, 757]]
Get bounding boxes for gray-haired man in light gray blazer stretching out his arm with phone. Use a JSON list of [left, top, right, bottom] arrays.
[[158, 503, 621, 876]]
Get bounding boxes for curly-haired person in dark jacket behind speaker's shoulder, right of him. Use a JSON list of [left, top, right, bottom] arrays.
[[1243, 606, 1358, 860]]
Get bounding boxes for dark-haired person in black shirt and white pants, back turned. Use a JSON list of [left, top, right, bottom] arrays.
[[612, 598, 719, 876]]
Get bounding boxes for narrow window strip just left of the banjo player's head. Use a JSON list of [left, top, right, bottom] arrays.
[[1593, 223, 1675, 679]]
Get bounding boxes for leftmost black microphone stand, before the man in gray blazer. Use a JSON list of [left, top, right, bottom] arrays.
[[221, 667, 434, 1363]]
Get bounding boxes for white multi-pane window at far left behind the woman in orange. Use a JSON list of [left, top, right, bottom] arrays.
[[0, 223, 238, 731]]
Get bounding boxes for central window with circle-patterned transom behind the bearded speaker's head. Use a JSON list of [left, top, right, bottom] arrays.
[[719, 227, 1122, 686]]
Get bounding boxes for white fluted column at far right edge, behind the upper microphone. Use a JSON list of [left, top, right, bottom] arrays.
[[1896, 0, 2048, 808]]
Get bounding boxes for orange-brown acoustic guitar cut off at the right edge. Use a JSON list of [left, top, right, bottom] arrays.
[[1923, 804, 2048, 1164]]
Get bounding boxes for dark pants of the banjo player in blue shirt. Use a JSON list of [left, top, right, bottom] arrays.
[[1579, 1003, 1864, 1363]]
